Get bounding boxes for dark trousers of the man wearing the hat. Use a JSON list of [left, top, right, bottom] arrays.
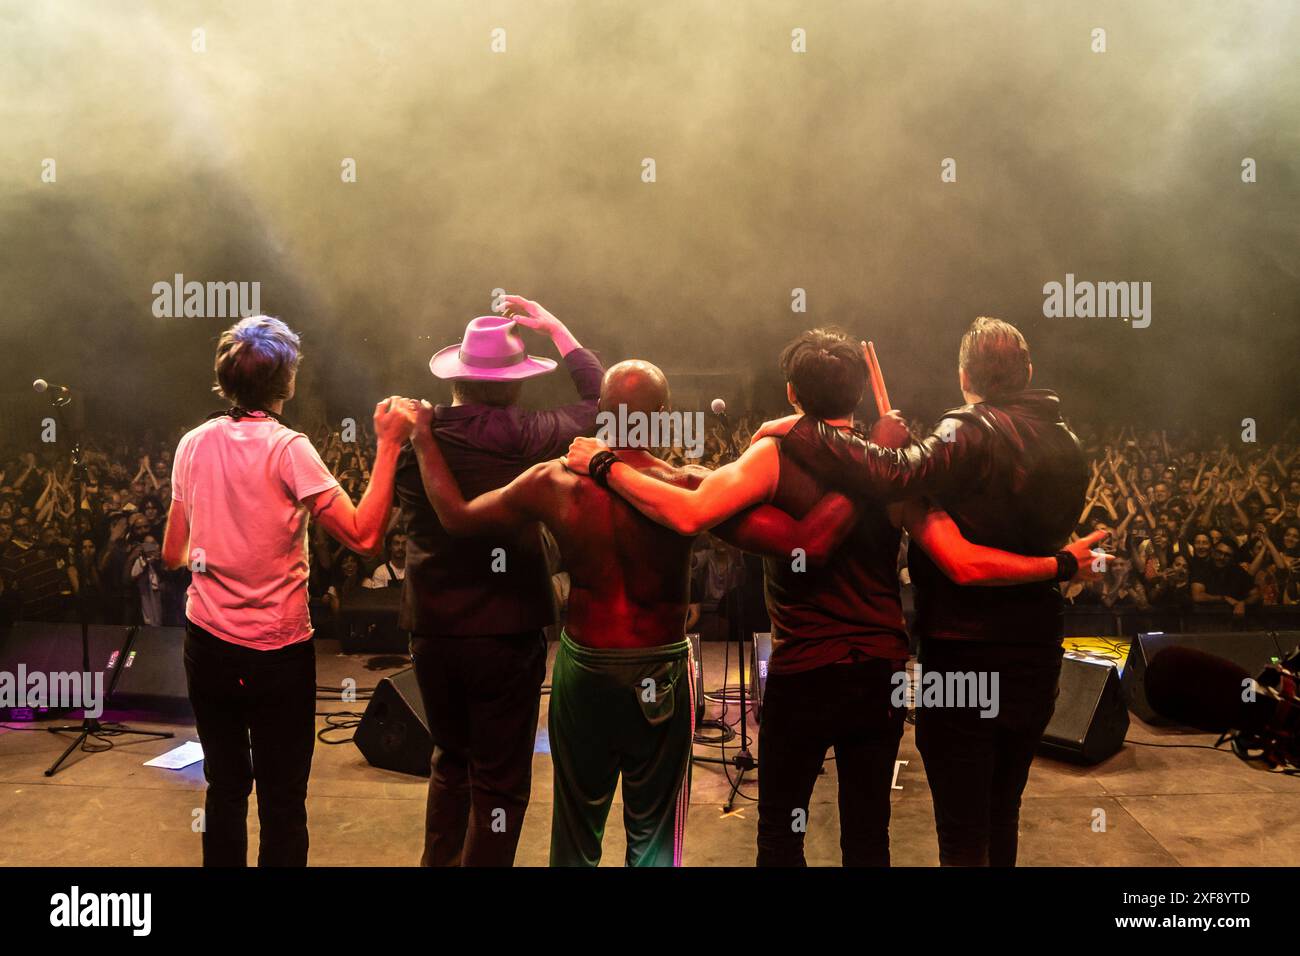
[[411, 631, 546, 866]]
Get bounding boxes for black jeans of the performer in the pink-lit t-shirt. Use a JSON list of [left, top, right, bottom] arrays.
[[185, 622, 316, 866]]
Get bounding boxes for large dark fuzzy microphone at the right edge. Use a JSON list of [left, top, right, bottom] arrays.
[[1145, 646, 1300, 766]]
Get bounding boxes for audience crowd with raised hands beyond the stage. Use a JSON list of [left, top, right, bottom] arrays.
[[0, 415, 1300, 626]]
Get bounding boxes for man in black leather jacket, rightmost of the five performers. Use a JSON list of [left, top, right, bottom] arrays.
[[758, 317, 1088, 866]]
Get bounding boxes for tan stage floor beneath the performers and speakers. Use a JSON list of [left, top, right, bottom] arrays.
[[0, 641, 1300, 866]]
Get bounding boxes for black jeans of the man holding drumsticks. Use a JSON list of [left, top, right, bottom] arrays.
[[758, 658, 906, 866]]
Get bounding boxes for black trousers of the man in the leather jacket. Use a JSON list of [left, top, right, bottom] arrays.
[[917, 639, 1062, 866]]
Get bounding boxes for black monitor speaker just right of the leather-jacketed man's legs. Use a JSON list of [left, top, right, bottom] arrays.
[[1039, 657, 1128, 763]]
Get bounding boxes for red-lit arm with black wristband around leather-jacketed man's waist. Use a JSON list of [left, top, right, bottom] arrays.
[[904, 499, 1110, 587]]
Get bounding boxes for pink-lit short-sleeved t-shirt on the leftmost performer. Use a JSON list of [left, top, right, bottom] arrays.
[[172, 416, 338, 650]]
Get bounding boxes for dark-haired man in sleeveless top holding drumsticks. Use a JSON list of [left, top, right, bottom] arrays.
[[567, 329, 1102, 866]]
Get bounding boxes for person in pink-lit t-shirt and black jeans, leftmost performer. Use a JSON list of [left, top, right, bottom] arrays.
[[163, 316, 412, 866]]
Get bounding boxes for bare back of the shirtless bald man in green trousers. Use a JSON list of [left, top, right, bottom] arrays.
[[529, 453, 693, 648]]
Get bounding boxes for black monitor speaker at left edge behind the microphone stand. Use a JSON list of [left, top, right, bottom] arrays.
[[0, 620, 133, 721]]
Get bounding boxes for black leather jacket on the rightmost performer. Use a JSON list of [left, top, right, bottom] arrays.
[[784, 389, 1088, 644]]
